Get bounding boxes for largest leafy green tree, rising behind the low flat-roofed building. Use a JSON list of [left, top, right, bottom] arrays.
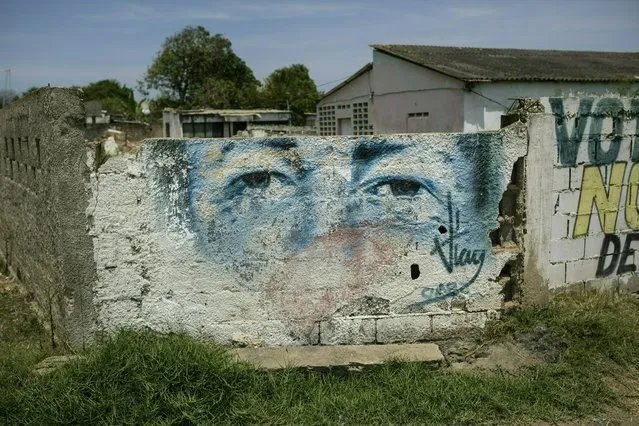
[[139, 26, 260, 107]]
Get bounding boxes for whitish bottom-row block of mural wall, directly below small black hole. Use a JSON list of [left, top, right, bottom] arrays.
[[377, 315, 433, 343]]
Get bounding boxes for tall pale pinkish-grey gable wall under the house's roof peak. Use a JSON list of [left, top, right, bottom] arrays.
[[372, 50, 464, 133]]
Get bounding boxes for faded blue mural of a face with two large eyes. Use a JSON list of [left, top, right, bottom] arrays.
[[149, 135, 503, 338]]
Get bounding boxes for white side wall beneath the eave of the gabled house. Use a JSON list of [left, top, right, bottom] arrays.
[[463, 81, 639, 132]]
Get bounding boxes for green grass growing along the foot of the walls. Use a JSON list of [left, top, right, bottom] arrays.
[[0, 282, 639, 425]]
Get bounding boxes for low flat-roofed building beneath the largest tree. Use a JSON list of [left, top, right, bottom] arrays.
[[162, 108, 291, 138]]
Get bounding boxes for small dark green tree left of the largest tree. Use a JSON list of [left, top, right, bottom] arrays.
[[82, 80, 137, 118]]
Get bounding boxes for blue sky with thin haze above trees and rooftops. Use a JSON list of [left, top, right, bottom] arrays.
[[0, 0, 639, 98]]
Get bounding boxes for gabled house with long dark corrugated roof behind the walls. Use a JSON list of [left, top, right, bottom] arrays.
[[317, 45, 639, 135]]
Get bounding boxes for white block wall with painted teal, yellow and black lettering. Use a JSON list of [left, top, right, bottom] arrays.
[[527, 97, 639, 291]]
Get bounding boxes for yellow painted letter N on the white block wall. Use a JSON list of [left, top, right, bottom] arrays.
[[572, 162, 626, 238]]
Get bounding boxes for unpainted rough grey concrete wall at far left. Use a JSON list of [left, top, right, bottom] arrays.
[[0, 88, 96, 346]]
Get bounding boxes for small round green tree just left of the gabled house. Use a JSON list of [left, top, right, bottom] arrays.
[[262, 64, 319, 126]]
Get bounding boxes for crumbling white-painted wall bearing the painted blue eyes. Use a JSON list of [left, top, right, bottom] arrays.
[[90, 126, 526, 345]]
